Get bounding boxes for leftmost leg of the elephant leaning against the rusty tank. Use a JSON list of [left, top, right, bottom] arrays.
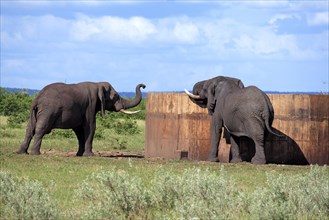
[[209, 114, 223, 162]]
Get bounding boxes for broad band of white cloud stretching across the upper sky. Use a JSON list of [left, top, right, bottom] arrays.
[[1, 13, 326, 59]]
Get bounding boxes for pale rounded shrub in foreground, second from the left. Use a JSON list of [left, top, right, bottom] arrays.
[[77, 170, 150, 219]]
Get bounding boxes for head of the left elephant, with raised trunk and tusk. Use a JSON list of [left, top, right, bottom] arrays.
[[98, 82, 146, 115]]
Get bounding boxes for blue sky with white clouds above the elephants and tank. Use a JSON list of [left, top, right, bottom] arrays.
[[1, 0, 329, 92]]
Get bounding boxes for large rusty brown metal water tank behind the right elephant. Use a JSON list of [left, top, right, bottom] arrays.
[[145, 93, 329, 164]]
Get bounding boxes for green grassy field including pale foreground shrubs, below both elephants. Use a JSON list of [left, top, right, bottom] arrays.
[[0, 117, 329, 219]]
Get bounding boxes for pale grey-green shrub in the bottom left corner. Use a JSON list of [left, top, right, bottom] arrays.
[[0, 171, 58, 219]]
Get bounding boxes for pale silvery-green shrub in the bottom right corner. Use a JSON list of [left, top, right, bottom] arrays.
[[249, 166, 329, 219]]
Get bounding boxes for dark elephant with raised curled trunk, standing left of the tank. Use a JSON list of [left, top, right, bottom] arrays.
[[17, 82, 146, 156]]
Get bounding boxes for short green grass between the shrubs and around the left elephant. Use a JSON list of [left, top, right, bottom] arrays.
[[0, 117, 329, 219]]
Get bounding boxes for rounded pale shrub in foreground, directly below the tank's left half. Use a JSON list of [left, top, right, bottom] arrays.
[[153, 168, 241, 219]]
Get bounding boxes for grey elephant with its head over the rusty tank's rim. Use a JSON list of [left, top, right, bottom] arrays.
[[187, 76, 280, 164]]
